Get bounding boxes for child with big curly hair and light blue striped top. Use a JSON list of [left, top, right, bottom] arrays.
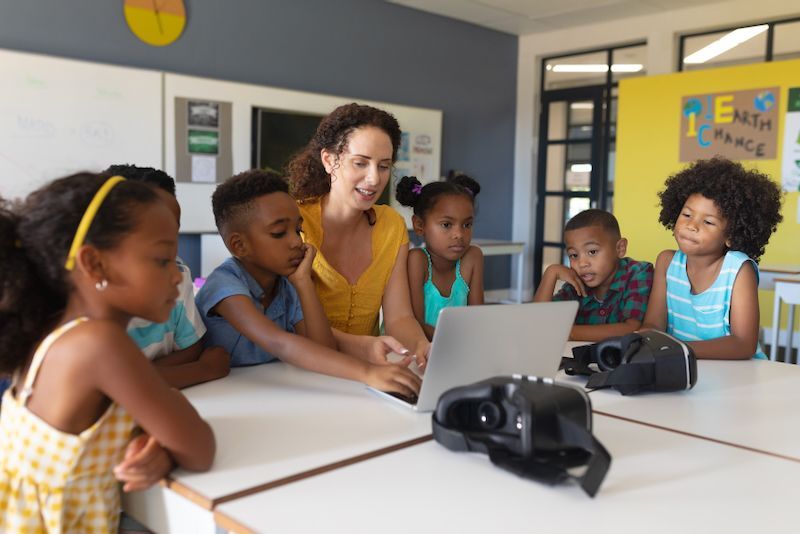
[[642, 157, 783, 360]]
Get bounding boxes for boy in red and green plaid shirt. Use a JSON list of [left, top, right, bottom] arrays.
[[533, 209, 653, 341]]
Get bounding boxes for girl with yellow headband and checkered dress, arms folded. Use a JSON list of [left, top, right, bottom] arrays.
[[0, 174, 215, 532]]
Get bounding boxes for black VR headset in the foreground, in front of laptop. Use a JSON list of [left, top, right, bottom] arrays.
[[433, 375, 611, 497]]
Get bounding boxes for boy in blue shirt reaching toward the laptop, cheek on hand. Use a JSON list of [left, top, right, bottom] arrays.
[[197, 170, 420, 395]]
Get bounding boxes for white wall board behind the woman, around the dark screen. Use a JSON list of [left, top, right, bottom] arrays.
[[164, 73, 442, 233]]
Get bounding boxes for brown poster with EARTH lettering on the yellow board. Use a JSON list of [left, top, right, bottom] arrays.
[[680, 87, 780, 162]]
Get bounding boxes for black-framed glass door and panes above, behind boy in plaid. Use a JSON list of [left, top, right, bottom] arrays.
[[534, 43, 647, 284]]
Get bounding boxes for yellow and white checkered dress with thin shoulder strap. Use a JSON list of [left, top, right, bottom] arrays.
[[0, 318, 134, 533]]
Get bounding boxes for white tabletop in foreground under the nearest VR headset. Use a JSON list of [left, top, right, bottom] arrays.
[[215, 416, 800, 534]]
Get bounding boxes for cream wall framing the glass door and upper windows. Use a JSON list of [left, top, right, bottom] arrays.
[[512, 0, 800, 296]]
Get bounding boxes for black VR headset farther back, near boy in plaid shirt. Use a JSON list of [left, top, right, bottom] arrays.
[[561, 330, 697, 395]]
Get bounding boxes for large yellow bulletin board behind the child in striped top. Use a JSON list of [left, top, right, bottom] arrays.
[[614, 60, 800, 324]]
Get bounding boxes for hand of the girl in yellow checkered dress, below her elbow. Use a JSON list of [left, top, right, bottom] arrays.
[[114, 434, 173, 491]]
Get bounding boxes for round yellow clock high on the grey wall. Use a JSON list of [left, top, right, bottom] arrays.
[[124, 0, 186, 46]]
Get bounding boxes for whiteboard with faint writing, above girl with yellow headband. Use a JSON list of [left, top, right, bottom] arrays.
[[0, 50, 163, 202]]
